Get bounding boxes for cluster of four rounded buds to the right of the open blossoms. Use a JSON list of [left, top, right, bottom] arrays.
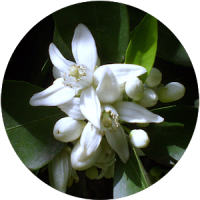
[[125, 68, 185, 108]]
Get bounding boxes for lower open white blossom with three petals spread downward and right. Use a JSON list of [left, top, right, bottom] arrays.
[[71, 101, 164, 170]]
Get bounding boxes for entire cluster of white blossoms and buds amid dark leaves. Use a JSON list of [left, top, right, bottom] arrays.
[[30, 24, 185, 193]]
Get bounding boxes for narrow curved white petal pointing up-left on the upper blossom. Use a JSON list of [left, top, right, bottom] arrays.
[[49, 43, 75, 72]]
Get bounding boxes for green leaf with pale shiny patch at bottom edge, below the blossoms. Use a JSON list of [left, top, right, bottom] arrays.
[[113, 148, 151, 199]]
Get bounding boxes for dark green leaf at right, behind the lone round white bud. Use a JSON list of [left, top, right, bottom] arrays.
[[142, 106, 198, 166]]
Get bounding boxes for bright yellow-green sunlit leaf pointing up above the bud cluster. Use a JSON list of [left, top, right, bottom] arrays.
[[125, 13, 158, 81]]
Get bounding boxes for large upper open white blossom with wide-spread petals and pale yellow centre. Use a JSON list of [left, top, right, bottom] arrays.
[[30, 24, 146, 128]]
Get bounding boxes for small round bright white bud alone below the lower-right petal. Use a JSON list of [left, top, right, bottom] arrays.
[[129, 129, 150, 148]]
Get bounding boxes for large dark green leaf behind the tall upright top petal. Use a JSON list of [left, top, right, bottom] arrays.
[[53, 1, 129, 64]]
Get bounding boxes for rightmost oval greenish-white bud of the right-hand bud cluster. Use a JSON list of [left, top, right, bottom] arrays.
[[158, 82, 185, 103]]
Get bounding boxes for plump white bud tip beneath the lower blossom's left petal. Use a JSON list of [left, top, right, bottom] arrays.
[[71, 141, 102, 170]]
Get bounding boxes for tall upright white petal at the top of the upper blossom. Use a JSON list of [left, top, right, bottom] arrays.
[[72, 24, 98, 72]]
